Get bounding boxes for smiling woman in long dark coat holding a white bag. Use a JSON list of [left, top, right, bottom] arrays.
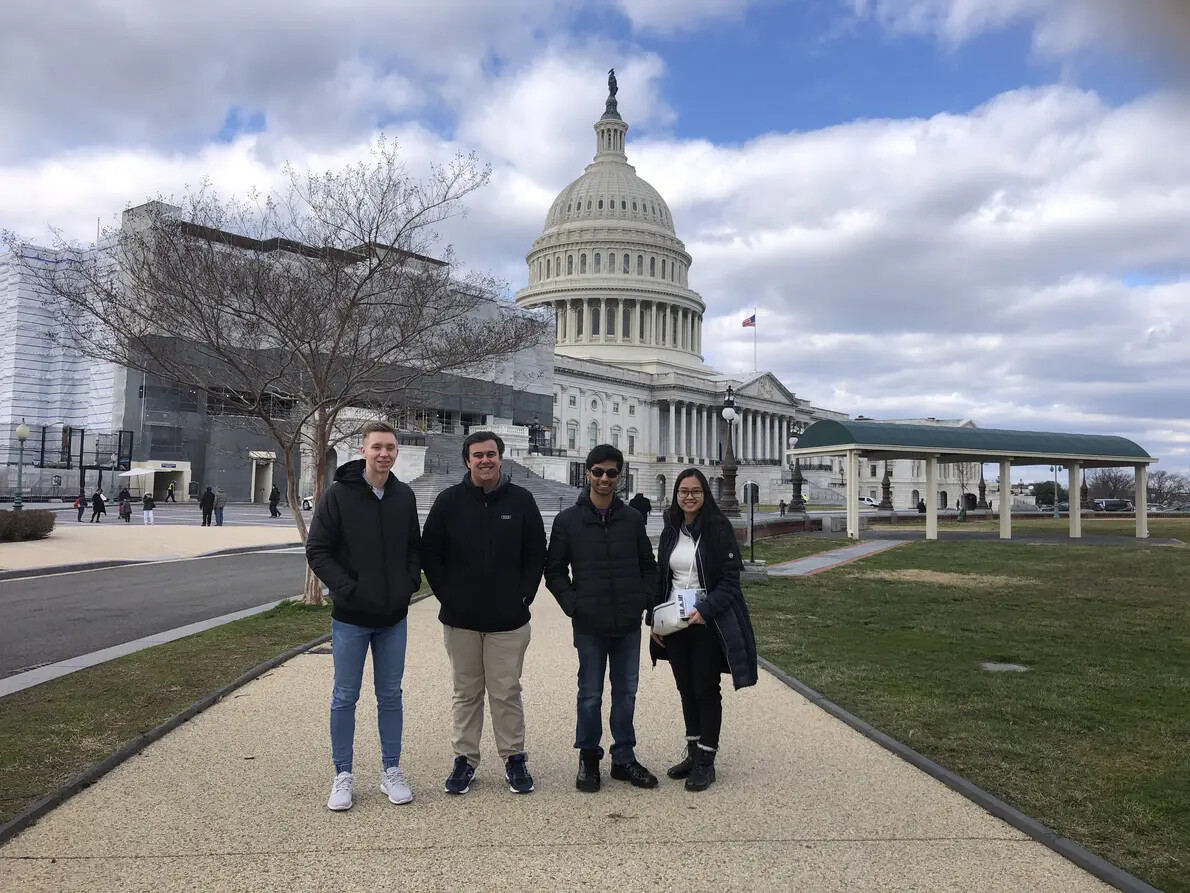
[[649, 468, 757, 791]]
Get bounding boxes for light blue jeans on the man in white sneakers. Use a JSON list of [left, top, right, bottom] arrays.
[[331, 619, 409, 774]]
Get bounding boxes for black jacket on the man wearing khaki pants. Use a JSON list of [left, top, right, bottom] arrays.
[[421, 473, 545, 632]]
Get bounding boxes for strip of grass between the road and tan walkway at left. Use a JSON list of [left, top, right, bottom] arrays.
[[0, 604, 331, 824]]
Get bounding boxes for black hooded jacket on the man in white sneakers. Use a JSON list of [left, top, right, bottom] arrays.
[[306, 458, 421, 626]]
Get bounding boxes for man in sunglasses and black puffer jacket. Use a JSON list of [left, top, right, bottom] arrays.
[[545, 444, 657, 792]]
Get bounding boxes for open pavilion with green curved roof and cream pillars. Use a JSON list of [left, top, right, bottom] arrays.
[[788, 419, 1157, 539]]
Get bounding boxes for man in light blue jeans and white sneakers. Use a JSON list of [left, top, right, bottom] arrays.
[[306, 421, 421, 811]]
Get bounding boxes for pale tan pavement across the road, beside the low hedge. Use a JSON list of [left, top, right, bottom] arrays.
[[0, 516, 300, 570]]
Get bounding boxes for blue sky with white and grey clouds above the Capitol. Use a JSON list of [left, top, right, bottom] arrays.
[[0, 0, 1190, 472]]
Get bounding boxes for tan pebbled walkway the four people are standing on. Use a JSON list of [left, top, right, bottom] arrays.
[[0, 591, 1110, 893]]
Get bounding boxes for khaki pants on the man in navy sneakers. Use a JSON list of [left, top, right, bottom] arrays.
[[443, 624, 530, 767]]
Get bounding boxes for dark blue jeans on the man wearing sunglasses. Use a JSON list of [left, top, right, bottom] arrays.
[[575, 626, 640, 763]]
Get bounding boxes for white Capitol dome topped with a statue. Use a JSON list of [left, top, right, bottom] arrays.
[[516, 74, 706, 368]]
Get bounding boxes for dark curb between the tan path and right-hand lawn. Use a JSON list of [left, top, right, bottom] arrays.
[[761, 657, 1160, 893]]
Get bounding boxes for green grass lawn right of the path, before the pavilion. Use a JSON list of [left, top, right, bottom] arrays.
[[746, 538, 1190, 891]]
